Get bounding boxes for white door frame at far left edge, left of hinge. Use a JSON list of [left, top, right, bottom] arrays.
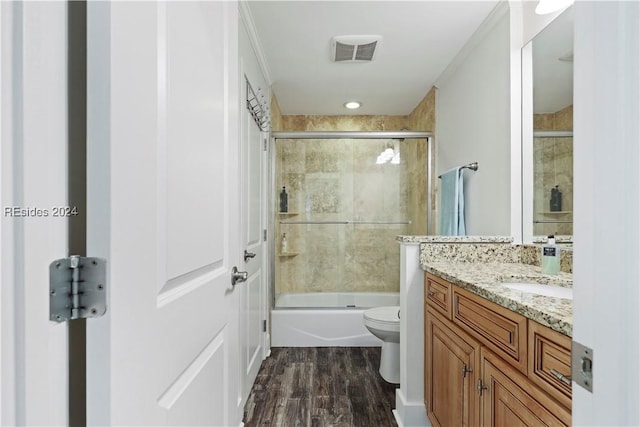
[[0, 2, 68, 425]]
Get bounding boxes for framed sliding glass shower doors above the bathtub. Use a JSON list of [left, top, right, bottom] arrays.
[[271, 132, 430, 308]]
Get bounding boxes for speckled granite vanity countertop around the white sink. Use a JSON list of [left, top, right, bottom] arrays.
[[421, 261, 573, 337]]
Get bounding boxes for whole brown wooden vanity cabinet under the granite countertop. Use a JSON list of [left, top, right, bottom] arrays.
[[424, 273, 571, 426]]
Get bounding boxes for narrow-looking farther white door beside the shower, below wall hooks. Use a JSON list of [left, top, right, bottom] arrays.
[[239, 79, 267, 403]]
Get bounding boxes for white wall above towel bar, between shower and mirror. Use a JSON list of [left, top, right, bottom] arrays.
[[436, 11, 511, 235]]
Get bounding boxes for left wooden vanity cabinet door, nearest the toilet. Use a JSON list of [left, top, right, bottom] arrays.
[[424, 309, 480, 426]]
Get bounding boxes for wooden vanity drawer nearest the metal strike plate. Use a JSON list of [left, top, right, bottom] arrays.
[[529, 320, 571, 408]]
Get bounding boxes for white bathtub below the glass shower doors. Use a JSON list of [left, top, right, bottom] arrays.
[[271, 292, 400, 347]]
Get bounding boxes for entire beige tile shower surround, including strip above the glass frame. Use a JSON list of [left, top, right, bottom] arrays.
[[271, 90, 435, 300]]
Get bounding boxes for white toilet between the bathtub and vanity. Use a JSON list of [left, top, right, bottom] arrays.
[[362, 306, 400, 384]]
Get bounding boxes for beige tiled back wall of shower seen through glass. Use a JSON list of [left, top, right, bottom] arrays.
[[276, 140, 407, 292]]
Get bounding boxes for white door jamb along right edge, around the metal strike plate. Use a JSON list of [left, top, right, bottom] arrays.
[[573, 1, 640, 426]]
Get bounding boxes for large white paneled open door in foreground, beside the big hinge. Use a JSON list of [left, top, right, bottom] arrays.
[[87, 1, 244, 426]]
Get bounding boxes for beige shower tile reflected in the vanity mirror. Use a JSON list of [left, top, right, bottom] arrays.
[[533, 105, 573, 235]]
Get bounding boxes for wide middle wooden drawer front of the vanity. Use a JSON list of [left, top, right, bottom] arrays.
[[453, 287, 527, 375]]
